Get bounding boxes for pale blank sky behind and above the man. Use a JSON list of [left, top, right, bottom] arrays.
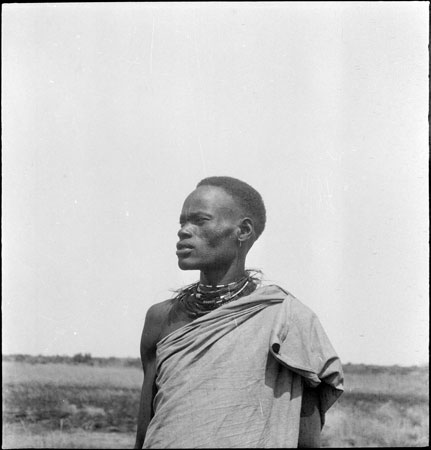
[[2, 2, 429, 365]]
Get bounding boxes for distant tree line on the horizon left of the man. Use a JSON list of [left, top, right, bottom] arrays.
[[2, 353, 141, 368]]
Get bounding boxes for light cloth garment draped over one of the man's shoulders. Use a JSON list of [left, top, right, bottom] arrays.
[[144, 285, 343, 448]]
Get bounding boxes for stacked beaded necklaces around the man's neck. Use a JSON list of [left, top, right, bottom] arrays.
[[177, 273, 256, 317]]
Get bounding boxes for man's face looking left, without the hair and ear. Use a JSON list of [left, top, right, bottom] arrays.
[[177, 186, 241, 272]]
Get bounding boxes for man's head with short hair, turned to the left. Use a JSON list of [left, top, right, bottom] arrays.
[[177, 177, 266, 272]]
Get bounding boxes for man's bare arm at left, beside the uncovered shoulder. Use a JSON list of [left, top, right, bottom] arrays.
[[134, 305, 160, 448]]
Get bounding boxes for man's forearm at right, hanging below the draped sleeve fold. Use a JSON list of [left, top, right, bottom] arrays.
[[298, 386, 322, 448]]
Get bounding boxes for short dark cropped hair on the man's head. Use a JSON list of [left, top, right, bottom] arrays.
[[196, 177, 266, 239]]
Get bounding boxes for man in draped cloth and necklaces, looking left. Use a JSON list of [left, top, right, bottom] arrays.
[[135, 177, 343, 448]]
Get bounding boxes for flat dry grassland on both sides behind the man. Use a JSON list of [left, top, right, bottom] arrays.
[[2, 357, 429, 448]]
